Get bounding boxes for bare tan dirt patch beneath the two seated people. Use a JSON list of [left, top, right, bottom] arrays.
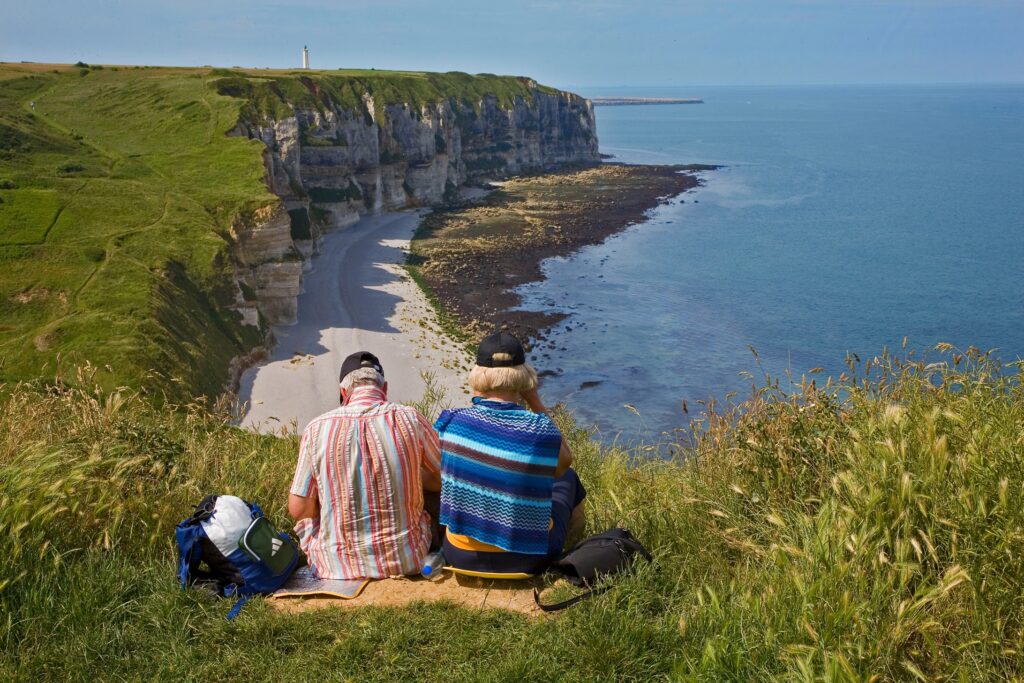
[[268, 574, 545, 617]]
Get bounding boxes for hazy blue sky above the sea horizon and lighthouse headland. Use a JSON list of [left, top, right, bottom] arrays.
[[0, 0, 1024, 89]]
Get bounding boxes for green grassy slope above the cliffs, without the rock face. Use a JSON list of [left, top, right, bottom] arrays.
[[0, 65, 550, 399]]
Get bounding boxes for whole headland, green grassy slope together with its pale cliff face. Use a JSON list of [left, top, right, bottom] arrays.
[[0, 63, 597, 400]]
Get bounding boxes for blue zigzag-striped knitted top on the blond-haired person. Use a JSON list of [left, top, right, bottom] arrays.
[[434, 397, 562, 555]]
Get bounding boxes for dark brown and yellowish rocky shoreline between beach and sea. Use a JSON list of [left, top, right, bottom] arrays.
[[409, 163, 717, 343]]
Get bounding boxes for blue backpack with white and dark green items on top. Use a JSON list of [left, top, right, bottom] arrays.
[[174, 496, 299, 620]]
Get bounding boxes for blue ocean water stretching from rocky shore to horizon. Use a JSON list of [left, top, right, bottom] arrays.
[[521, 85, 1024, 440]]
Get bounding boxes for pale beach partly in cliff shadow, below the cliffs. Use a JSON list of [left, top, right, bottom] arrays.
[[239, 212, 470, 432]]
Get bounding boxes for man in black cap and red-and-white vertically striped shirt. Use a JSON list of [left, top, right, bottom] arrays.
[[288, 351, 441, 579]]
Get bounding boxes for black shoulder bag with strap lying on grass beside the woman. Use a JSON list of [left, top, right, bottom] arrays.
[[534, 528, 651, 612]]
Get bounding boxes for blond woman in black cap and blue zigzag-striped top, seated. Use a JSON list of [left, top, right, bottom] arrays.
[[434, 332, 587, 573]]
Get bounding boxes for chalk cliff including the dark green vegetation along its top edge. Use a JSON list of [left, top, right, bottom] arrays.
[[215, 74, 599, 325]]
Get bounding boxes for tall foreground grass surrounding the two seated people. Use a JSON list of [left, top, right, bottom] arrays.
[[0, 349, 1024, 681]]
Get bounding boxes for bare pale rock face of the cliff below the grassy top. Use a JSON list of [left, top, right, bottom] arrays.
[[224, 82, 600, 325]]
